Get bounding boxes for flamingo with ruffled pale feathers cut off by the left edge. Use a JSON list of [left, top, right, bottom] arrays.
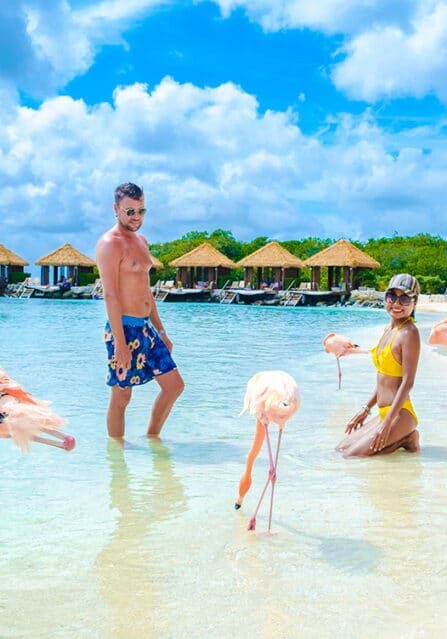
[[0, 368, 76, 451]]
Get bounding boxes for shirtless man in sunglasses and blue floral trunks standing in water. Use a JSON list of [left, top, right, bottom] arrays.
[[96, 183, 184, 437]]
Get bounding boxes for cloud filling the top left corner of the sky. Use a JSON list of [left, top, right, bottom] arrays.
[[0, 0, 170, 98]]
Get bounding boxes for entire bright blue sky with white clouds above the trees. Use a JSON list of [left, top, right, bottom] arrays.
[[0, 0, 447, 261]]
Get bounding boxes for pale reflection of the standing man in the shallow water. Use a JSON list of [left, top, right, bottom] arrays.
[[94, 440, 186, 639]]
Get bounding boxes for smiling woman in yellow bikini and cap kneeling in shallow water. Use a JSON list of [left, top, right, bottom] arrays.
[[337, 273, 420, 457]]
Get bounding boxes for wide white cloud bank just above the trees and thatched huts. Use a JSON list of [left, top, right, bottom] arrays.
[[0, 78, 447, 259]]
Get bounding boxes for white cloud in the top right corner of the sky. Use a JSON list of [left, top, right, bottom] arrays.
[[216, 0, 447, 102]]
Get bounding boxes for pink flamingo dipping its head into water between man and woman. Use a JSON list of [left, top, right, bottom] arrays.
[[234, 371, 300, 533]]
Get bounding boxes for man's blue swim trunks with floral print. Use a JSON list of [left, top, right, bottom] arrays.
[[104, 315, 177, 388]]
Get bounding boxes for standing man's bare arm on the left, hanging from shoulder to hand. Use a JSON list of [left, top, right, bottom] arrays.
[[96, 239, 132, 379]]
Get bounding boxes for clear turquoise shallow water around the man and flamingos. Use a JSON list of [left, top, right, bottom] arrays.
[[0, 299, 447, 639]]
